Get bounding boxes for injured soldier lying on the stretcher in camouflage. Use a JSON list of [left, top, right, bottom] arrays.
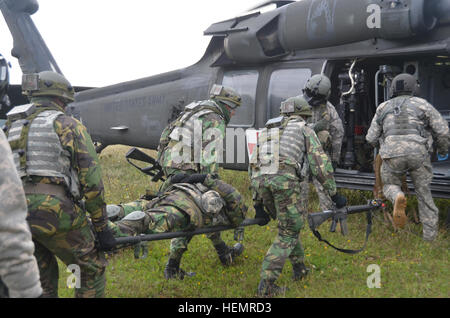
[[112, 174, 247, 279]]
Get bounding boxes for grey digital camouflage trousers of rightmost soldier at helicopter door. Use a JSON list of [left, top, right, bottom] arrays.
[[381, 155, 439, 240]]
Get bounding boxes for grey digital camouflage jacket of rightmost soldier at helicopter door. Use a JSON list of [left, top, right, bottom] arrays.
[[366, 96, 449, 159]]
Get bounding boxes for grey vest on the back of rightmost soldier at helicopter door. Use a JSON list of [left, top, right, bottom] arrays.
[[377, 96, 426, 138]]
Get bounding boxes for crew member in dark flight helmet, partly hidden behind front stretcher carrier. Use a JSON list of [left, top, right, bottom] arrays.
[[301, 74, 344, 211]]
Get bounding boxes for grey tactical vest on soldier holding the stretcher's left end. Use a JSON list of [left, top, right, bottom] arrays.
[[7, 104, 80, 199]]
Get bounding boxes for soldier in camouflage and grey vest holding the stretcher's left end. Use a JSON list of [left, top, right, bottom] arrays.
[[6, 71, 115, 297]]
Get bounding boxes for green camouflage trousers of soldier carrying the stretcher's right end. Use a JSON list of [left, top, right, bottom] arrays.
[[251, 175, 305, 280]]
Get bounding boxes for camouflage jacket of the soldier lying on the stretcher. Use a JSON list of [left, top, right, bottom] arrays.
[[147, 175, 247, 228]]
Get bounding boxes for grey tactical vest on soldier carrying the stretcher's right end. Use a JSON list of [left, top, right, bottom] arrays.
[[256, 115, 306, 177]]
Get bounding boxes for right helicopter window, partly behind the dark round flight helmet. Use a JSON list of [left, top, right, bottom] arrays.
[[267, 68, 311, 118]]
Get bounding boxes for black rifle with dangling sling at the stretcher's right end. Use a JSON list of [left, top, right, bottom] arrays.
[[308, 199, 383, 254]]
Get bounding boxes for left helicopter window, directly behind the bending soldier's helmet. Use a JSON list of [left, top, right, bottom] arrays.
[[222, 70, 258, 127]]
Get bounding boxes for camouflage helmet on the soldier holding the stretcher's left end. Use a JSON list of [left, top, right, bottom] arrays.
[[22, 71, 75, 102]]
